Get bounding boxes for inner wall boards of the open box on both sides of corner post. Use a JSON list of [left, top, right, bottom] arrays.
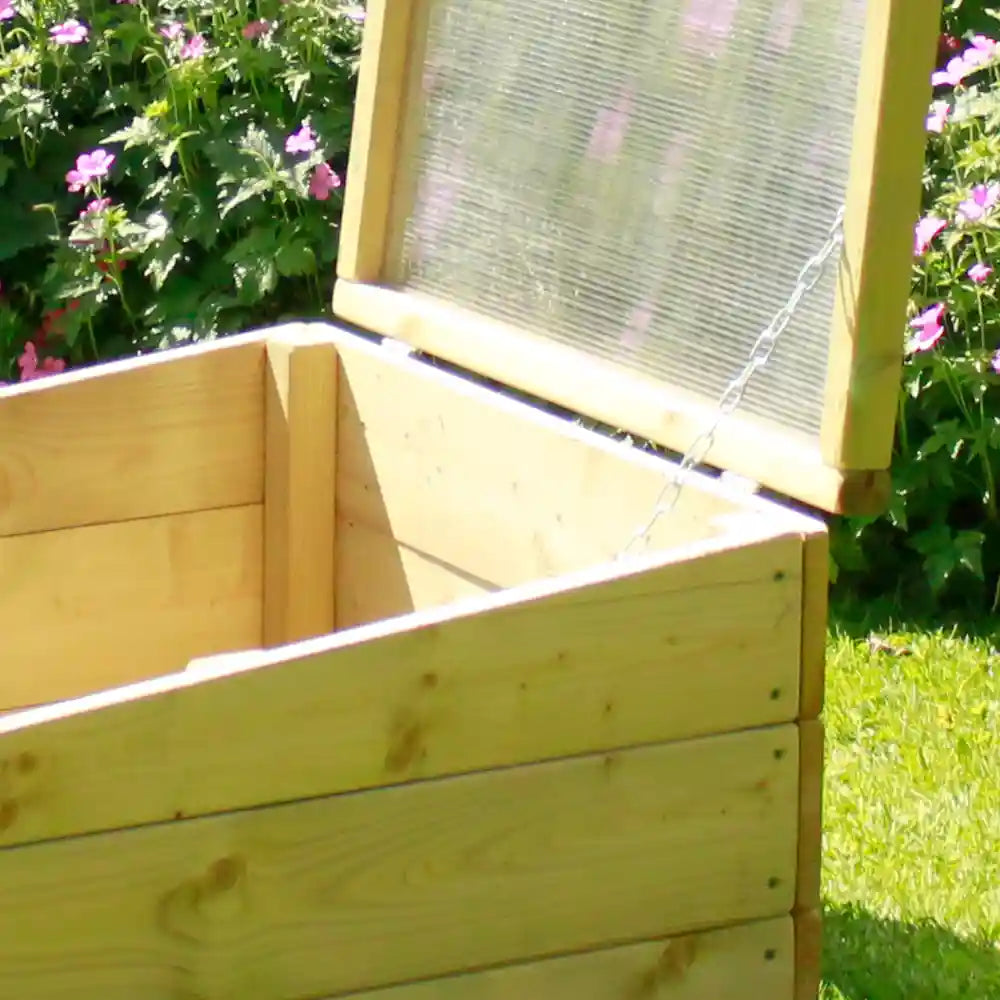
[[0, 326, 801, 711]]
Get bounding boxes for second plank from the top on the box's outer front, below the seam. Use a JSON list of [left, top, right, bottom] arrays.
[[0, 725, 798, 1000]]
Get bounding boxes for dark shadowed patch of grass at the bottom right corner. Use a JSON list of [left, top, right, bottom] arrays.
[[823, 905, 1000, 1000]]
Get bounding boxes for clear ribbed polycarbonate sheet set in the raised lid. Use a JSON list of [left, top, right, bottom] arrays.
[[400, 0, 866, 435]]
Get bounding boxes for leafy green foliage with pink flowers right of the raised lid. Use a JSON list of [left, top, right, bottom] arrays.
[[832, 13, 1000, 609]]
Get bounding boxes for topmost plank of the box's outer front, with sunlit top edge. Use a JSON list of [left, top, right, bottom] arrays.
[[0, 534, 802, 844]]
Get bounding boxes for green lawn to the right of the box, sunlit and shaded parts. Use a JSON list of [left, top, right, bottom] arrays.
[[821, 616, 1000, 1000]]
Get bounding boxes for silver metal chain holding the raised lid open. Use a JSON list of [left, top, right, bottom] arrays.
[[619, 207, 844, 558]]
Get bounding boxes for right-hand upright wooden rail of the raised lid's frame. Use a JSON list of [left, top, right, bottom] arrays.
[[821, 0, 941, 469]]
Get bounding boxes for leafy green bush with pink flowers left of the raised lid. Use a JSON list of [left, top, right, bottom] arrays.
[[0, 0, 364, 381]]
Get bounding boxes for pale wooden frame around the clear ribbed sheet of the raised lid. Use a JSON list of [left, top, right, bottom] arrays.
[[333, 0, 940, 513]]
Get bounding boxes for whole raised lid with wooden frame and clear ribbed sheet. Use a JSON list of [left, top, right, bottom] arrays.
[[334, 0, 941, 511]]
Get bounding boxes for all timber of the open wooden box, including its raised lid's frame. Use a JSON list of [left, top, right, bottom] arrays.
[[0, 0, 938, 1000]]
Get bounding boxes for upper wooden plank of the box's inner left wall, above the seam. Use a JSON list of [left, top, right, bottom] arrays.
[[0, 335, 264, 536]]
